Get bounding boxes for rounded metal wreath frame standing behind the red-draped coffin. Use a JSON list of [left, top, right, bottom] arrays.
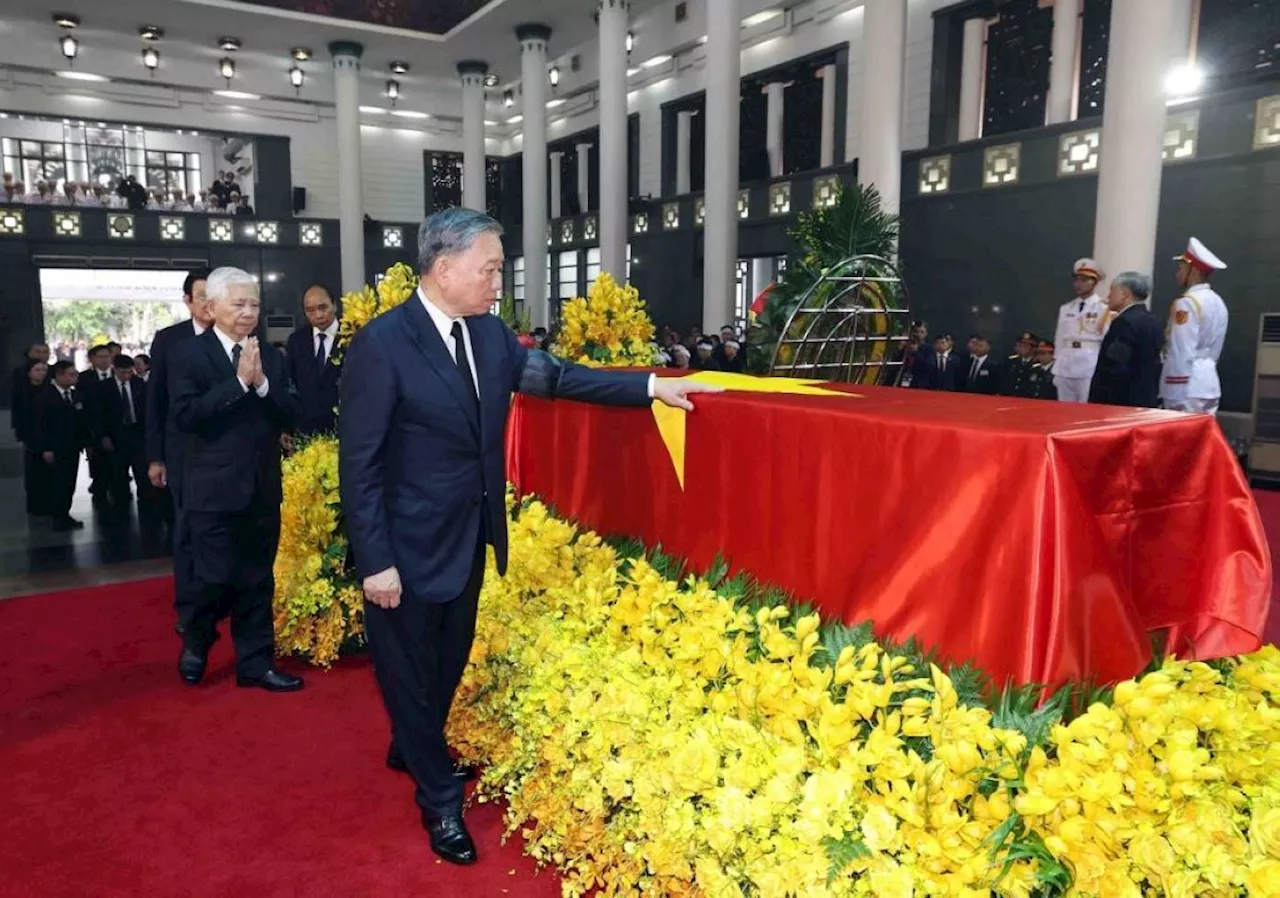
[[769, 256, 911, 385]]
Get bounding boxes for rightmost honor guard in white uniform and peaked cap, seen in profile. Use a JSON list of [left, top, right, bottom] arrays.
[[1160, 237, 1228, 414]]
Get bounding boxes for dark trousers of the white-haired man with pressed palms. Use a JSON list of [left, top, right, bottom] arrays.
[[184, 494, 280, 678]]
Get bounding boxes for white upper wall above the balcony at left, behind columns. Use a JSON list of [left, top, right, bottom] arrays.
[[0, 73, 502, 221]]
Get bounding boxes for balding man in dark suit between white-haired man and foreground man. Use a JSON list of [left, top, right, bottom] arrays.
[[284, 285, 342, 437]]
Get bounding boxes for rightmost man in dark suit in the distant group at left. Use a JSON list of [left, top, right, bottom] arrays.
[[90, 353, 151, 510]]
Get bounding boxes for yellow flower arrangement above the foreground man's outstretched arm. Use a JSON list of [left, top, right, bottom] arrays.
[[552, 271, 658, 367]]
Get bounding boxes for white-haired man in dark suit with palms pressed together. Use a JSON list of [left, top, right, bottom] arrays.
[[169, 267, 302, 692]]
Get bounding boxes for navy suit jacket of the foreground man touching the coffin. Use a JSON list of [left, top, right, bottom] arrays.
[[338, 295, 652, 603]]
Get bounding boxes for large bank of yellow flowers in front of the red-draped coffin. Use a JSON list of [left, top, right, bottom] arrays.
[[451, 501, 1280, 898]]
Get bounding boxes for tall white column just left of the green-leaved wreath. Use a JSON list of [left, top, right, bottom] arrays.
[[703, 0, 742, 329]]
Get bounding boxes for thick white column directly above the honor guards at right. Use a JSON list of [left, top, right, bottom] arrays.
[[1093, 0, 1172, 275]]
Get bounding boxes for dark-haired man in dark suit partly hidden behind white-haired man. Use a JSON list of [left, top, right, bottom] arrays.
[[145, 269, 214, 633]]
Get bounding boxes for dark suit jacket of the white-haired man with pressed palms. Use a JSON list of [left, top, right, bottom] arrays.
[[169, 330, 298, 512]]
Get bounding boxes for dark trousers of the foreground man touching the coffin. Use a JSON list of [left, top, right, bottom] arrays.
[[365, 539, 485, 817]]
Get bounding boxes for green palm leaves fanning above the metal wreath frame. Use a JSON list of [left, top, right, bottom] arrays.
[[748, 184, 899, 374]]
